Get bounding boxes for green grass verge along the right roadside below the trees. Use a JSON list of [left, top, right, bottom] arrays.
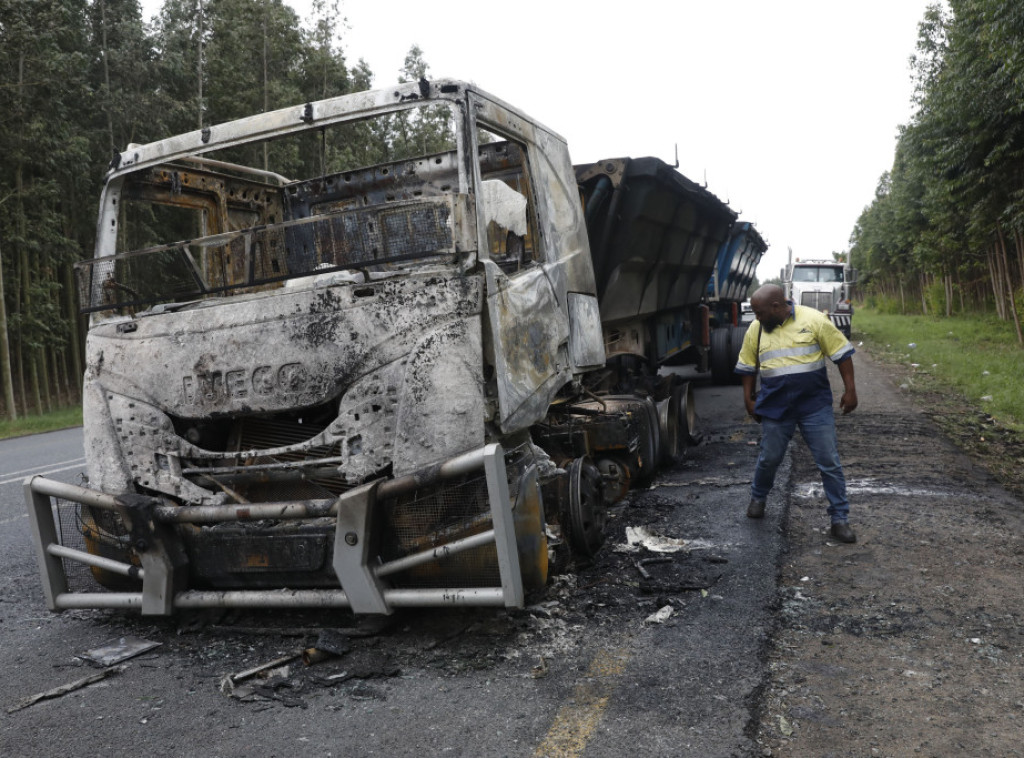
[[853, 307, 1024, 431]]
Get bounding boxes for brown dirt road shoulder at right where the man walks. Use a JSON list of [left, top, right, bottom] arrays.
[[757, 351, 1024, 758]]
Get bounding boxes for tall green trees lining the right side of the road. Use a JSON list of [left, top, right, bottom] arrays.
[[851, 0, 1024, 335]]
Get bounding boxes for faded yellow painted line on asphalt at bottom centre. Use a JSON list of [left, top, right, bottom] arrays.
[[534, 646, 630, 758]]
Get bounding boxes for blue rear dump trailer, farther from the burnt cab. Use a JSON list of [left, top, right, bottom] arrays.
[[708, 221, 768, 384]]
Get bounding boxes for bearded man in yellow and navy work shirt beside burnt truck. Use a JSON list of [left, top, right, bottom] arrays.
[[736, 285, 857, 543]]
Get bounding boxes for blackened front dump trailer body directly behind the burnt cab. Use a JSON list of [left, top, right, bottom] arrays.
[[575, 158, 736, 385]]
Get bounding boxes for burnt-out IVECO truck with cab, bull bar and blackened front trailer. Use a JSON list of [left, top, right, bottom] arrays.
[[25, 80, 734, 615]]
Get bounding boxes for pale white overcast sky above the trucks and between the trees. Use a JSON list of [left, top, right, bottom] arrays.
[[143, 0, 930, 280]]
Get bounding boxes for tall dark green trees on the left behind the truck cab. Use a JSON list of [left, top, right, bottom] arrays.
[[0, 0, 444, 418]]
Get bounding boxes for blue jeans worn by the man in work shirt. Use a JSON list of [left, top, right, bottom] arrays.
[[751, 406, 850, 523]]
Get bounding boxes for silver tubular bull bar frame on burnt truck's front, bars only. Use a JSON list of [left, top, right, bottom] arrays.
[[25, 444, 523, 616]]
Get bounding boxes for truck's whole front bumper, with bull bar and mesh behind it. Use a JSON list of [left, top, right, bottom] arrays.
[[25, 444, 547, 616]]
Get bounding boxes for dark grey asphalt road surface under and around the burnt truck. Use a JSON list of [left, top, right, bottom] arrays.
[[0, 383, 788, 758]]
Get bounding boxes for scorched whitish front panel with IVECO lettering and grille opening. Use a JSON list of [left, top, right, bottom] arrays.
[[84, 271, 484, 503]]
